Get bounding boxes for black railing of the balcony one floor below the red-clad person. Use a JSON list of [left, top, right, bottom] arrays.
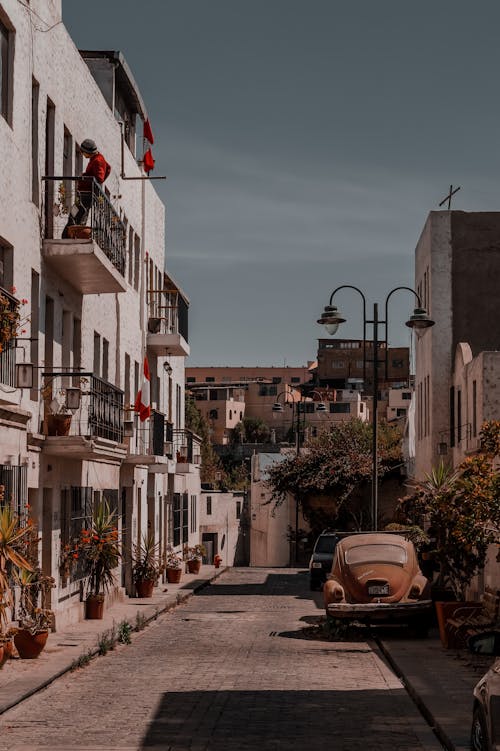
[[42, 372, 124, 443]]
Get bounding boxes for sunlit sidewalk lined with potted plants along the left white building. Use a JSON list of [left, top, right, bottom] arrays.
[[0, 566, 226, 714]]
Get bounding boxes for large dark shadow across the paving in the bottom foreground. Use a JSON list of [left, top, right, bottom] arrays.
[[141, 689, 432, 751]]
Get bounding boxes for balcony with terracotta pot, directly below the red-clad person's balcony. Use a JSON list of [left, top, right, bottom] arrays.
[[40, 372, 126, 460]]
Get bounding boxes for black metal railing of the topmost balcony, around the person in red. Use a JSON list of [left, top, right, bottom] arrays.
[[43, 176, 126, 275]]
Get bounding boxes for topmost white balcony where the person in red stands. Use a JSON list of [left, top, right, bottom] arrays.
[[42, 177, 127, 295]]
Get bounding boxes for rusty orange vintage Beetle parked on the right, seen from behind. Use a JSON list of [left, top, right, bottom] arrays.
[[323, 532, 432, 636]]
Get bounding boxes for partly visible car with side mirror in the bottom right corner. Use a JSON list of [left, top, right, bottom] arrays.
[[469, 631, 500, 751]]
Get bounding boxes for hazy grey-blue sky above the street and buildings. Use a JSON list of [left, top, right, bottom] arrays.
[[63, 0, 500, 366]]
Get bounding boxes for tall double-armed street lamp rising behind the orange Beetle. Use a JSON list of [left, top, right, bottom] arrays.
[[317, 284, 434, 530]]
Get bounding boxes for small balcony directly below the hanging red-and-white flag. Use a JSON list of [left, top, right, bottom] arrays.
[[126, 409, 175, 473]]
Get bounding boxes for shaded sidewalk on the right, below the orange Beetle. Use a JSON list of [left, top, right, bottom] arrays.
[[378, 631, 494, 751]]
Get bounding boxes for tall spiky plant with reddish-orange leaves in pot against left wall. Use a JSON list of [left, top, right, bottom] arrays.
[[79, 500, 121, 619]]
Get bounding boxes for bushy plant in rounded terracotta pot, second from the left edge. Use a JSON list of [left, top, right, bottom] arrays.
[[14, 567, 55, 659]]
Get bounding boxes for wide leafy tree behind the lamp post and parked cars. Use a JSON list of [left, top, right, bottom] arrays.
[[268, 420, 401, 529]]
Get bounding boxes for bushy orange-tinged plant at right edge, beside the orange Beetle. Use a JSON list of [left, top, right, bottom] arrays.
[[401, 421, 500, 599]]
